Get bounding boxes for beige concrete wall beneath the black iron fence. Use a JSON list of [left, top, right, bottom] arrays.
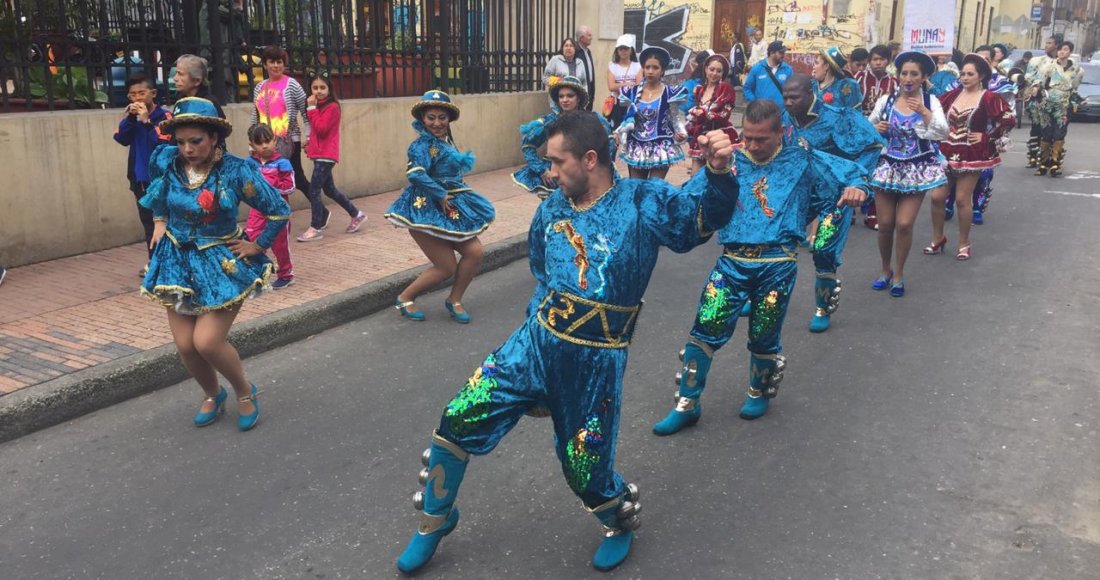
[[0, 92, 547, 267]]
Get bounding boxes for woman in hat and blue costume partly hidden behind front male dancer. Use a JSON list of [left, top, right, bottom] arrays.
[[512, 77, 615, 198]]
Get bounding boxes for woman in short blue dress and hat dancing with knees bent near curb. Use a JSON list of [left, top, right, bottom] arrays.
[[384, 90, 496, 324]]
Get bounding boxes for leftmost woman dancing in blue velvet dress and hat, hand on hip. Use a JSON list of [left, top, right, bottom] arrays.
[[140, 97, 290, 431]]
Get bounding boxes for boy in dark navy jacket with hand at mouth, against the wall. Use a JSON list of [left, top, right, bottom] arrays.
[[114, 73, 172, 270]]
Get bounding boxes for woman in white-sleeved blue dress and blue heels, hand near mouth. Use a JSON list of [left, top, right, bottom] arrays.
[[869, 52, 947, 298]]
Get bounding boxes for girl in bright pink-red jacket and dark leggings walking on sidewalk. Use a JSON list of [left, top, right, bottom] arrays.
[[298, 70, 366, 242]]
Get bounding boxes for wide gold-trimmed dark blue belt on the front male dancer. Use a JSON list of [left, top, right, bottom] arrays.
[[537, 291, 641, 349]]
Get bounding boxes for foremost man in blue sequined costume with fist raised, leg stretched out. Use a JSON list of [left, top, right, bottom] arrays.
[[397, 112, 737, 573]]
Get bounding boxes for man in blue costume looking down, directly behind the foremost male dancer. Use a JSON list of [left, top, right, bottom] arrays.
[[653, 100, 869, 435]]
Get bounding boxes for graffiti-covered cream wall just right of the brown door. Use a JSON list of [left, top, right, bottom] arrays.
[[765, 0, 867, 53]]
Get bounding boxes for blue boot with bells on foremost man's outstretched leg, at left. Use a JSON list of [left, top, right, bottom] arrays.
[[397, 433, 470, 574]]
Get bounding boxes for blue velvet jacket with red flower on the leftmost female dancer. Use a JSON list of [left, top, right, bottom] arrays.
[[140, 145, 290, 250]]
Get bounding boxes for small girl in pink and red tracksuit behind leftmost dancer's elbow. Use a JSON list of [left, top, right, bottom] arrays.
[[244, 124, 294, 289]]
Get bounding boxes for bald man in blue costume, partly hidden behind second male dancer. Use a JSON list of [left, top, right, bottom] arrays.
[[783, 75, 886, 332]]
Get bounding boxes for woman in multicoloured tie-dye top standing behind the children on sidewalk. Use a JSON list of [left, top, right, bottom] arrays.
[[251, 46, 309, 196]]
